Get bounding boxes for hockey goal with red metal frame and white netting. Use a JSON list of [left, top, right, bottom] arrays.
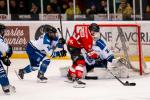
[[75, 24, 146, 75]]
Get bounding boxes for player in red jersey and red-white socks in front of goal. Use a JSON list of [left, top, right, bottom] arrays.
[[67, 23, 99, 87]]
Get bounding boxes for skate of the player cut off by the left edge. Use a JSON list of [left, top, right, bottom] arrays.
[[2, 85, 16, 95]]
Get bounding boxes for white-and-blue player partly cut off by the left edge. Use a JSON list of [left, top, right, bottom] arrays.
[[0, 24, 15, 94]]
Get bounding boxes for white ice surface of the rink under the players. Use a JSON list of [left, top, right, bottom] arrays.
[[0, 59, 150, 100]]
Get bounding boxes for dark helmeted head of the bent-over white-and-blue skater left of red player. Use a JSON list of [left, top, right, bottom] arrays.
[[45, 26, 58, 40]]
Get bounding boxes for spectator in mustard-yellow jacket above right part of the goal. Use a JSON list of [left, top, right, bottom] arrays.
[[117, 0, 133, 20]]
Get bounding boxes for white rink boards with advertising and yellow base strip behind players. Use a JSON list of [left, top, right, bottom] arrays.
[[1, 21, 150, 61]]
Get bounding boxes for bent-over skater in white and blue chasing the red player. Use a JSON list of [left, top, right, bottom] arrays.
[[18, 26, 67, 82]]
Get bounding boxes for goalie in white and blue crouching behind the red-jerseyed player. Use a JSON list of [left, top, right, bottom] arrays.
[[83, 36, 125, 72]]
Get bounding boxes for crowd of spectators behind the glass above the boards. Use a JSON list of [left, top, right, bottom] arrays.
[[0, 0, 150, 20]]
